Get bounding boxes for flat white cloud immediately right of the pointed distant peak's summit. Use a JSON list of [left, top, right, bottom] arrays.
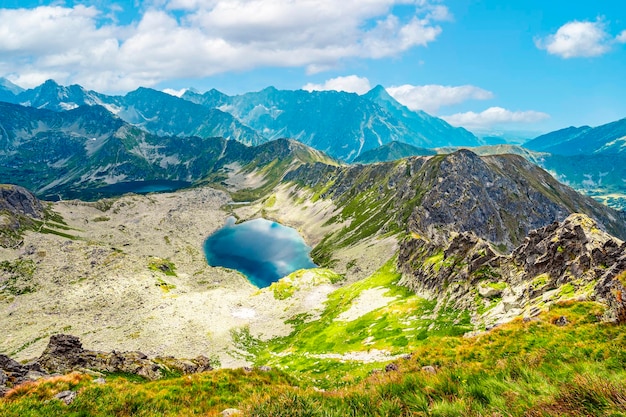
[[387, 84, 493, 113]]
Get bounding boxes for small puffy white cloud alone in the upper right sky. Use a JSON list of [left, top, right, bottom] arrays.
[[535, 20, 626, 58]]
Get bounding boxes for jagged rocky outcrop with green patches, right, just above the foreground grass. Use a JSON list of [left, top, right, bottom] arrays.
[[398, 214, 626, 326]]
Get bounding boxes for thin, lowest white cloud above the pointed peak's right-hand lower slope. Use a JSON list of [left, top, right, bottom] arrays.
[[442, 107, 550, 129]]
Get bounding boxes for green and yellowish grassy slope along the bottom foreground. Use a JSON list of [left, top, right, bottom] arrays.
[[0, 302, 626, 417]]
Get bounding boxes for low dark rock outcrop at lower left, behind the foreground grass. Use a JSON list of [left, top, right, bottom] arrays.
[[0, 334, 213, 396]]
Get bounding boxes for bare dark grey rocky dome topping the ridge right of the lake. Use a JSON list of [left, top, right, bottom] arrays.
[[410, 150, 569, 249]]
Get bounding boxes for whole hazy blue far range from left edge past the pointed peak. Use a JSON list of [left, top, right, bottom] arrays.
[[0, 80, 482, 161]]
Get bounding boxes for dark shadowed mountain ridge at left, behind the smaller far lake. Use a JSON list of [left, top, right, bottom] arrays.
[[0, 103, 337, 198]]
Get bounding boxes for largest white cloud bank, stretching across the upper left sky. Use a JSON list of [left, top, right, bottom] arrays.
[[0, 0, 450, 91]]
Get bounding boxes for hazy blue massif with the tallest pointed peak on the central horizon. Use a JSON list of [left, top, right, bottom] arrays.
[[182, 86, 482, 161]]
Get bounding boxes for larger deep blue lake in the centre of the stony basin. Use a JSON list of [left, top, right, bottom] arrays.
[[204, 217, 317, 288]]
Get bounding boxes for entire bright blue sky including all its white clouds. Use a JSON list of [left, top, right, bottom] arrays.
[[0, 0, 626, 132]]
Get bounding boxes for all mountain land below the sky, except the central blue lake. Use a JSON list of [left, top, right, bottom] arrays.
[[0, 81, 626, 416]]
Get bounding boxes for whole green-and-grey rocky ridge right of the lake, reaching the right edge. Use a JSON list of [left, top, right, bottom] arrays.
[[284, 150, 626, 256]]
